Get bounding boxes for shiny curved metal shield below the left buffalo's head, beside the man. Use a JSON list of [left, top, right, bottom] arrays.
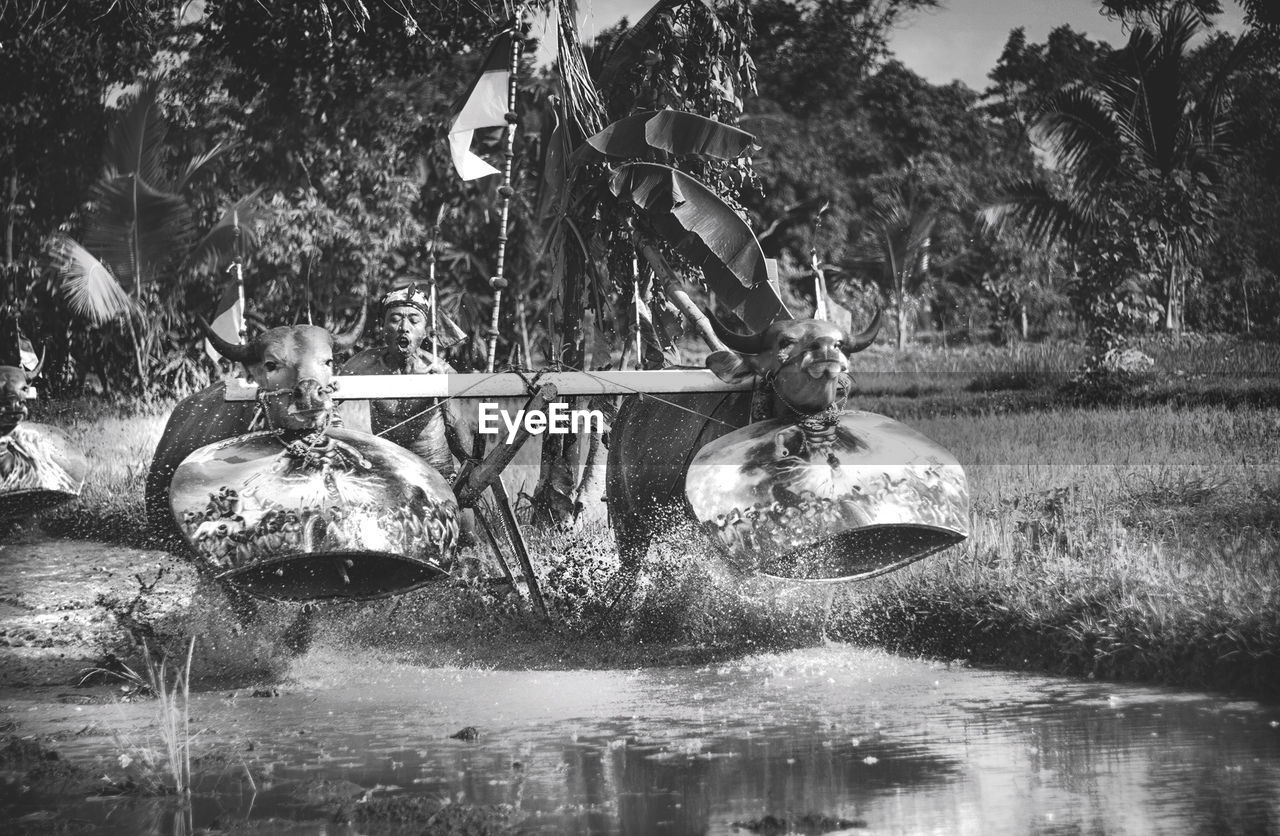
[[170, 429, 458, 600]]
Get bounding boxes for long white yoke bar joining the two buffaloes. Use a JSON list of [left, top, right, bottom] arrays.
[[225, 369, 753, 401]]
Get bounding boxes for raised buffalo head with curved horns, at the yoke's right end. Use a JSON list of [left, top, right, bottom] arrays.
[[707, 305, 881, 417]]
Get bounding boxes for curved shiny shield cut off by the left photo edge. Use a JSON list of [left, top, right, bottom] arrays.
[[0, 421, 88, 520]]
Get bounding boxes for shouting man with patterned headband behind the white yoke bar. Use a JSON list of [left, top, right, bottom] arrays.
[[339, 284, 474, 483]]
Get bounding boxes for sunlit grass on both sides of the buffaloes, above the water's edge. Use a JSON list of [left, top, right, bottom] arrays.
[[17, 337, 1280, 698]]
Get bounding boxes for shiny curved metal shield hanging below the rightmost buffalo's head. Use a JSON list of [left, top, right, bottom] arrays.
[[685, 411, 969, 581]]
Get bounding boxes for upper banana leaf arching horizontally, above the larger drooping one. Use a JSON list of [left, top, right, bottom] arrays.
[[573, 109, 755, 163]]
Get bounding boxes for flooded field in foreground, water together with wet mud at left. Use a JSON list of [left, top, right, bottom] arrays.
[[0, 543, 1280, 836]]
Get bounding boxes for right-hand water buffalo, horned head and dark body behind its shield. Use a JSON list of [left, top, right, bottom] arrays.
[[605, 312, 881, 572]]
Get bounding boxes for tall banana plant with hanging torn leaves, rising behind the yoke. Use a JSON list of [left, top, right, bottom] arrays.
[[534, 0, 785, 520]]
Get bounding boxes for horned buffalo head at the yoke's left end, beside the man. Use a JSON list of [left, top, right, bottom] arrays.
[[200, 310, 365, 431]]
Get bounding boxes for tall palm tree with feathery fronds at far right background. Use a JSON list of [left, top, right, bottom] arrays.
[[984, 3, 1256, 330]]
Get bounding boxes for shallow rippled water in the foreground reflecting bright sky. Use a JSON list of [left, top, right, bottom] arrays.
[[4, 647, 1280, 835]]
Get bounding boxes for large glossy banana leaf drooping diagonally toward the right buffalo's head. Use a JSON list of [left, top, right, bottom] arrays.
[[609, 163, 788, 329]]
